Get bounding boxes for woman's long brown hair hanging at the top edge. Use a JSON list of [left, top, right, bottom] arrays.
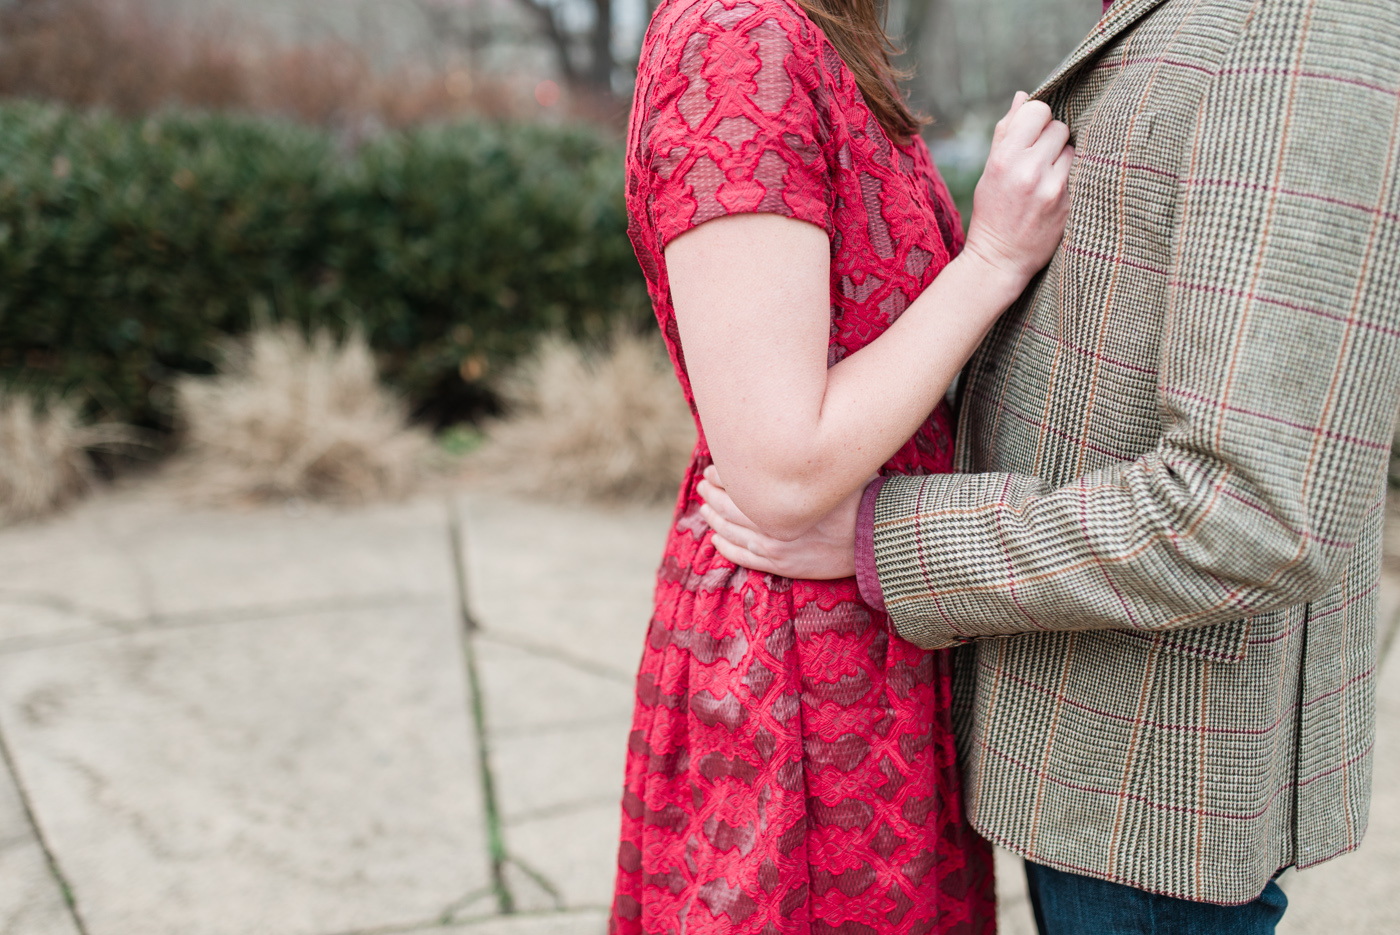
[[797, 0, 928, 143]]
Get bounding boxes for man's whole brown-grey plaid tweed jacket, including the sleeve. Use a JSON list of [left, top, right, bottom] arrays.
[[874, 0, 1400, 904]]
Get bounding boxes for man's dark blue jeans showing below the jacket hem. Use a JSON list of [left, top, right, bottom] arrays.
[[1026, 861, 1288, 935]]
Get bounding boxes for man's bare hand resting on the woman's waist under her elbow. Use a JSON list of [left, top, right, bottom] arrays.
[[699, 465, 865, 579]]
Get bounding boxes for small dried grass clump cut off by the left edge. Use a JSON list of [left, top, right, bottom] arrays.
[[0, 393, 134, 525]]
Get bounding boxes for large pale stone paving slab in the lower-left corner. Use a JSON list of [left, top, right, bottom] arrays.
[[0, 603, 490, 935]]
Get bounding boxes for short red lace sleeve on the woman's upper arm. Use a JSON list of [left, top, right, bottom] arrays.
[[638, 0, 832, 248]]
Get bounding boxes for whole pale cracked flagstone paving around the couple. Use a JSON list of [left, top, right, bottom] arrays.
[[0, 488, 1400, 935]]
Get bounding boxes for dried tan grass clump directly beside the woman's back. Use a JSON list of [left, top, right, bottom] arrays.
[[480, 333, 694, 502]]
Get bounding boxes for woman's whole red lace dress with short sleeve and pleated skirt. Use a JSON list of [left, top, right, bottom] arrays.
[[610, 0, 995, 935]]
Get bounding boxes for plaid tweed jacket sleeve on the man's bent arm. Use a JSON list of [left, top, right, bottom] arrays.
[[874, 0, 1400, 647]]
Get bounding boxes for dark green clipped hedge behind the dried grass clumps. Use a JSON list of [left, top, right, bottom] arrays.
[[0, 104, 645, 427]]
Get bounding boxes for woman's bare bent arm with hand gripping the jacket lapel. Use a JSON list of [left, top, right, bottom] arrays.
[[666, 95, 1074, 539]]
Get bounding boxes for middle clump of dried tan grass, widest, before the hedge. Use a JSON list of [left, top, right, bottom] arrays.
[[176, 328, 428, 501]]
